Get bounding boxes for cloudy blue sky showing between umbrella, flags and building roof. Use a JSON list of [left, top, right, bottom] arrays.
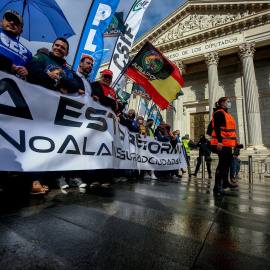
[[21, 0, 186, 64]]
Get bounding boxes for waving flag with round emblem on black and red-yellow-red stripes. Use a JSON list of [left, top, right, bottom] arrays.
[[126, 42, 184, 110]]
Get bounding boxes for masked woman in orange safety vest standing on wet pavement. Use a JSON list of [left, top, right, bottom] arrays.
[[211, 97, 237, 195]]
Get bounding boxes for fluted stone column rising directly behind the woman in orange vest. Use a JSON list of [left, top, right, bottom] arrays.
[[204, 52, 220, 119]]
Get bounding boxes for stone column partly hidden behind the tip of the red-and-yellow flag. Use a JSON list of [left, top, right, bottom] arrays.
[[172, 60, 185, 132]]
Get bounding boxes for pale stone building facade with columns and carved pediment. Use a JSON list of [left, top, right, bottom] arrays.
[[99, 0, 270, 157]]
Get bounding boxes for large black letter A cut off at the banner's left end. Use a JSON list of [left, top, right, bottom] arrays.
[[0, 78, 33, 120]]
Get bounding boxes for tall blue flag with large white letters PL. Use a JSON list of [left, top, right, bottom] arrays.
[[73, 0, 120, 82]]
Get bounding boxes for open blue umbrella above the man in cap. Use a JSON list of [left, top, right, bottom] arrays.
[[0, 0, 75, 42]]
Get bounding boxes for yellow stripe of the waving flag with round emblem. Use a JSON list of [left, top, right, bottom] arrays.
[[149, 76, 181, 103]]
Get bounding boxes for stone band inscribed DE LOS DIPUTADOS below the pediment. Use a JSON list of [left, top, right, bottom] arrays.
[[165, 34, 245, 61]]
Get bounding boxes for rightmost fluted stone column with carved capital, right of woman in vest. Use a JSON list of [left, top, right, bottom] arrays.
[[238, 43, 264, 148]]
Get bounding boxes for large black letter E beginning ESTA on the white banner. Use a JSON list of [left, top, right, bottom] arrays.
[[54, 96, 84, 127]]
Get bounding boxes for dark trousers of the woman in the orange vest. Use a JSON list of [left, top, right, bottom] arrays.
[[215, 146, 233, 188]]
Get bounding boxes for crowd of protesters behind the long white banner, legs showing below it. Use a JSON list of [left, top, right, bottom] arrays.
[[0, 10, 238, 195]]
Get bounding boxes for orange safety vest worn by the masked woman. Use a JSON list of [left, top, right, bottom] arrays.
[[211, 110, 237, 147]]
